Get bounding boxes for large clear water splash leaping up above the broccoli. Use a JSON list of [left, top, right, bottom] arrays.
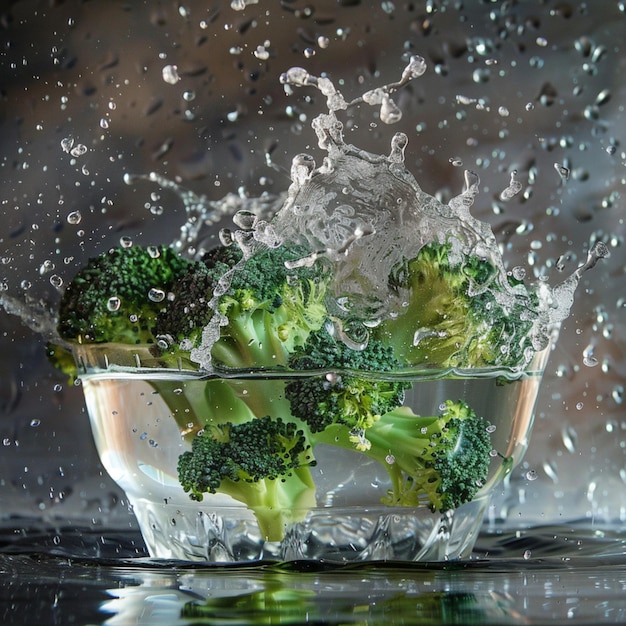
[[192, 56, 608, 369]]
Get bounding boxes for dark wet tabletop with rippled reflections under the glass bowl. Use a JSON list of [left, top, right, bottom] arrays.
[[0, 525, 626, 626]]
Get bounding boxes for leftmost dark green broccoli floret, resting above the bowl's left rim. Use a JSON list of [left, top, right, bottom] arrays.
[[58, 245, 193, 344]]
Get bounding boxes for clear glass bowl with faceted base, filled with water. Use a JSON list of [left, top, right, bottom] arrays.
[[74, 344, 550, 562]]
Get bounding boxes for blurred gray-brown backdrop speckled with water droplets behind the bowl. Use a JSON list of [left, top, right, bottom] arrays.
[[0, 0, 626, 528]]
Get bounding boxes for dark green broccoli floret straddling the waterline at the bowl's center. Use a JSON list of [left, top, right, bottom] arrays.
[[285, 326, 409, 450]]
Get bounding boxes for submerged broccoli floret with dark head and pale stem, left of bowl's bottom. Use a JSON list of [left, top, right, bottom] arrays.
[[178, 416, 315, 541]]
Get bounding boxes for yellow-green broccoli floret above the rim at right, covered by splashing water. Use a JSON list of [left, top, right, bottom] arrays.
[[375, 241, 537, 368]]
